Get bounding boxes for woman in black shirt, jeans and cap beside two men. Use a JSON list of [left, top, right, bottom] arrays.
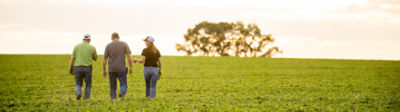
[[133, 36, 161, 98]]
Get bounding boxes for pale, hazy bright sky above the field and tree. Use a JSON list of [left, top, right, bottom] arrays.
[[0, 0, 400, 60]]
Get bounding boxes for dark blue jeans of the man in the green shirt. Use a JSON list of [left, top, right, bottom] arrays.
[[74, 67, 92, 100]]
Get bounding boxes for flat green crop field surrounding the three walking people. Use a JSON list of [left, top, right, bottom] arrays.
[[0, 55, 400, 111]]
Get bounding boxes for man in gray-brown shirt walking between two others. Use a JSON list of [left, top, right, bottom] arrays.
[[103, 32, 132, 99]]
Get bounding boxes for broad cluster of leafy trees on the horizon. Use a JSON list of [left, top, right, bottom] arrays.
[[176, 21, 282, 57]]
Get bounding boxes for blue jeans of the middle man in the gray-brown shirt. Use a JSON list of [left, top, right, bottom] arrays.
[[108, 71, 128, 99]]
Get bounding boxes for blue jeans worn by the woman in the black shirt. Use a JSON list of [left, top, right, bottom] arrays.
[[143, 67, 160, 98]]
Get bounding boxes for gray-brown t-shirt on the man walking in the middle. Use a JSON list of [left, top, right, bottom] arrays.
[[104, 40, 131, 72]]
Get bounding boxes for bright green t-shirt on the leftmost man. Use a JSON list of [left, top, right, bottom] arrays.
[[71, 42, 97, 66]]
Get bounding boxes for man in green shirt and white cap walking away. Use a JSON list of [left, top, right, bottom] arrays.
[[70, 34, 97, 100]]
